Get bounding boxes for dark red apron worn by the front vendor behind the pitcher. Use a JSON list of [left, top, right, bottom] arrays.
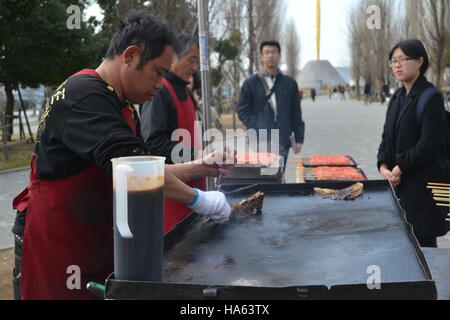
[[13, 70, 136, 299]]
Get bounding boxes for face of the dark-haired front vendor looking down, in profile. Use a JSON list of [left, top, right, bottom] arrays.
[[120, 46, 174, 104]]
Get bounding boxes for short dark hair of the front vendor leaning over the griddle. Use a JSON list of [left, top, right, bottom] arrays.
[[106, 11, 176, 69]]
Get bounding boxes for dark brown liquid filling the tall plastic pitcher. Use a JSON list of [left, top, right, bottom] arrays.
[[114, 187, 164, 281]]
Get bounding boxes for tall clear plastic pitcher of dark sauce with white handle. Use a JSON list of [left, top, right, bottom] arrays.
[[112, 156, 165, 282]]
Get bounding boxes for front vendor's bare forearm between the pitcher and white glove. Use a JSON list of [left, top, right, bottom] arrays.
[[164, 165, 195, 204]]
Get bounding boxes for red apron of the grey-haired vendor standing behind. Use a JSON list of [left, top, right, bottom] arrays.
[[163, 79, 206, 234]]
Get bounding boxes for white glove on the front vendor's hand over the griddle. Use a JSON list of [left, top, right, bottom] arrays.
[[188, 189, 231, 222]]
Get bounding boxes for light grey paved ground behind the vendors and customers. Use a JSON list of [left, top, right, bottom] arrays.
[[0, 97, 450, 249]]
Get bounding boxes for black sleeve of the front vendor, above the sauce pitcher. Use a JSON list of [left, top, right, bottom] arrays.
[[62, 94, 145, 175]]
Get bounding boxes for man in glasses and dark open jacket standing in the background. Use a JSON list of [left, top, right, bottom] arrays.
[[237, 41, 305, 163]]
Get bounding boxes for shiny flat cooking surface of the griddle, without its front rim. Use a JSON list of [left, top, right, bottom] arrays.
[[163, 188, 430, 287]]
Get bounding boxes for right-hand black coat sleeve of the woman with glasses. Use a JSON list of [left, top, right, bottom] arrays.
[[396, 94, 446, 172]]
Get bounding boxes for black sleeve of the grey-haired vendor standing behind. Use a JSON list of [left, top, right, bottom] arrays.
[[141, 89, 195, 164]]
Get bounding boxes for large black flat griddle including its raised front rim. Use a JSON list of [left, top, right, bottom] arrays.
[[106, 181, 437, 299]]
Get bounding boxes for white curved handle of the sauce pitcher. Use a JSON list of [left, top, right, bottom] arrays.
[[116, 164, 133, 239]]
